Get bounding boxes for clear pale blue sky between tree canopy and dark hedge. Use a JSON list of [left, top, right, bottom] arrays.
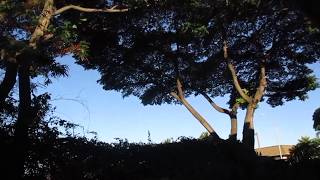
[[40, 56, 320, 147]]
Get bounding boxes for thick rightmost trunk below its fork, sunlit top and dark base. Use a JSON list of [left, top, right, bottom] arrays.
[[242, 103, 255, 149]]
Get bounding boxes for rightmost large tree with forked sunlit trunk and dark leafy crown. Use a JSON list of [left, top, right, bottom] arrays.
[[213, 2, 319, 148]]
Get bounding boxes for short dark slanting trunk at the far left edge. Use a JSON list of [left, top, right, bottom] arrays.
[[0, 62, 18, 112]]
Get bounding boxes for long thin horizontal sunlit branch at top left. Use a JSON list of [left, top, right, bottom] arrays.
[[54, 5, 128, 15]]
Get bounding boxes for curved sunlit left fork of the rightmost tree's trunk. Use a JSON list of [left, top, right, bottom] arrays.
[[223, 41, 251, 102]]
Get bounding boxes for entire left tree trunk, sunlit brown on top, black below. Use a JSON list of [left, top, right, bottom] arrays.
[[11, 0, 54, 179]]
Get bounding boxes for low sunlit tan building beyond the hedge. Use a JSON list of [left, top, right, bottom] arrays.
[[255, 145, 293, 160]]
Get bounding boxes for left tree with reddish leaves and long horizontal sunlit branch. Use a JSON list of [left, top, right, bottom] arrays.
[[0, 0, 128, 179]]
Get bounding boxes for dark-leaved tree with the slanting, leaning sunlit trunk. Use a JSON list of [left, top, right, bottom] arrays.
[[73, 1, 238, 138]]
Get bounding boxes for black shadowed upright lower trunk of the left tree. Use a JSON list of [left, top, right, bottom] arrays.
[[13, 59, 32, 179]]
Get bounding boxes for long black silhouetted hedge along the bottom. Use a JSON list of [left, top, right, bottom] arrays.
[[0, 121, 320, 180]]
